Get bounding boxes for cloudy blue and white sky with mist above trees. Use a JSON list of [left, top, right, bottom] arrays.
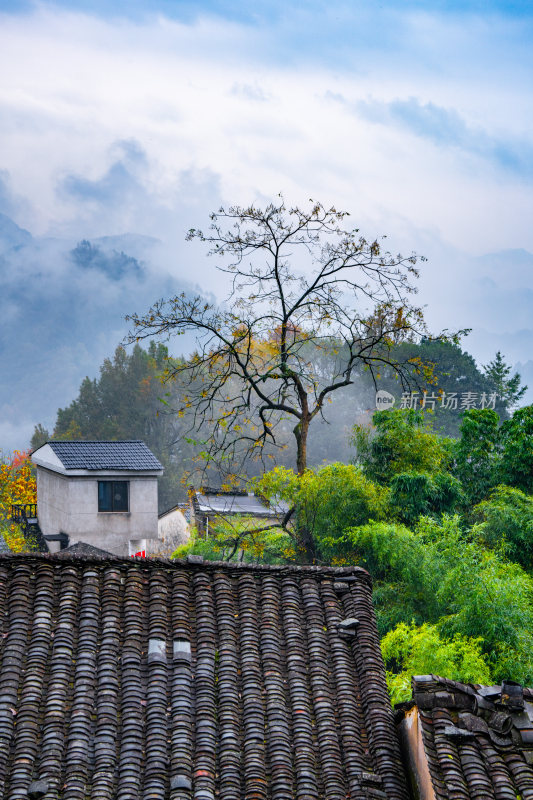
[[0, 0, 533, 450]]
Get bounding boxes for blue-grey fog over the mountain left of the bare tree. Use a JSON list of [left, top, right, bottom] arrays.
[[0, 215, 193, 450]]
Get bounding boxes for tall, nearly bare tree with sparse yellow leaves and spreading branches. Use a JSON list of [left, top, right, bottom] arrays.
[[128, 198, 453, 484]]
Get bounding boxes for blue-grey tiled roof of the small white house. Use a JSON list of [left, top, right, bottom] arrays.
[[35, 440, 163, 470]]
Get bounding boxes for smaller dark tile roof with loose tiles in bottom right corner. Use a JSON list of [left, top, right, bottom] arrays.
[[400, 675, 533, 800]]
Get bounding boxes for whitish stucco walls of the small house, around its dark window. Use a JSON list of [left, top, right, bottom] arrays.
[[37, 467, 157, 556]]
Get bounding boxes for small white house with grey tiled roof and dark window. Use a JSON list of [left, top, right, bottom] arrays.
[[31, 441, 163, 556]]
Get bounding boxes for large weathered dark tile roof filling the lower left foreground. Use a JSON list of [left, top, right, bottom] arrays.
[[0, 554, 408, 800]]
